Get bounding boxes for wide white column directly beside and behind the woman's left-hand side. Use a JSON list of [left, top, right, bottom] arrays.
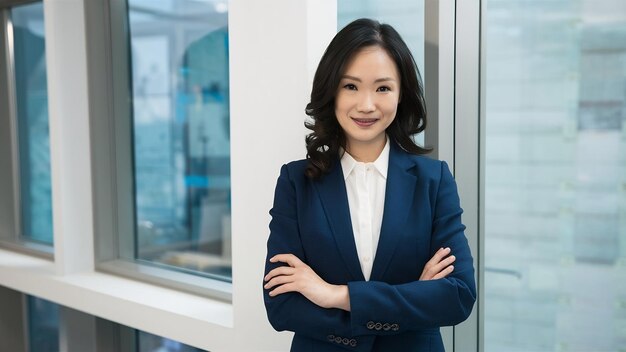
[[229, 0, 337, 351]]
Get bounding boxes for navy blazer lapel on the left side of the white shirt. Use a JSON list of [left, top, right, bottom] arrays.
[[315, 161, 365, 281]]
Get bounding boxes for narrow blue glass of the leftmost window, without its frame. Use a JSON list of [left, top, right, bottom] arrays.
[[11, 2, 53, 244]]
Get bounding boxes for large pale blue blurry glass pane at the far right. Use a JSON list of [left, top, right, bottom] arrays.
[[483, 0, 626, 351]]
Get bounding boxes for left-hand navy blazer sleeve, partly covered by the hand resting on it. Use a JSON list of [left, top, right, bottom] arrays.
[[263, 165, 374, 351]]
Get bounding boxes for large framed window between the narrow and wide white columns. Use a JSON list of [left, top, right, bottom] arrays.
[[92, 0, 232, 298]]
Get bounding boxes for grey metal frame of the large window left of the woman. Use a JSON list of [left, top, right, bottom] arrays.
[[85, 0, 232, 302]]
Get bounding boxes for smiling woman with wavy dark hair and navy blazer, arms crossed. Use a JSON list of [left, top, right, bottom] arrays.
[[264, 19, 476, 352]]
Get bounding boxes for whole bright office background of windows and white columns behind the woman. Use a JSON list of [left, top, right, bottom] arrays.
[[0, 0, 626, 352]]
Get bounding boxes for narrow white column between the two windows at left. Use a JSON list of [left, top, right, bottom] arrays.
[[44, 0, 94, 274]]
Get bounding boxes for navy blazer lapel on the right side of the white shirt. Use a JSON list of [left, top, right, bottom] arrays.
[[368, 142, 417, 281]]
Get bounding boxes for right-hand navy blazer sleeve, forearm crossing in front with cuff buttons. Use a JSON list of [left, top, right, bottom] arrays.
[[348, 162, 476, 335]]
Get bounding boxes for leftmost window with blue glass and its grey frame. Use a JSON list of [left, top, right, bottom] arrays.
[[0, 2, 53, 252]]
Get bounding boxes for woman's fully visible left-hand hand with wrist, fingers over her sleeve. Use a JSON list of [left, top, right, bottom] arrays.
[[263, 254, 350, 311]]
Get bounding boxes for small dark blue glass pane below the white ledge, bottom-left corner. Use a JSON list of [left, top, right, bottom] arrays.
[[28, 296, 59, 352]]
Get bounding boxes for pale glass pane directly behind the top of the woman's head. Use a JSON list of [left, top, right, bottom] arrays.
[[337, 0, 425, 145]]
